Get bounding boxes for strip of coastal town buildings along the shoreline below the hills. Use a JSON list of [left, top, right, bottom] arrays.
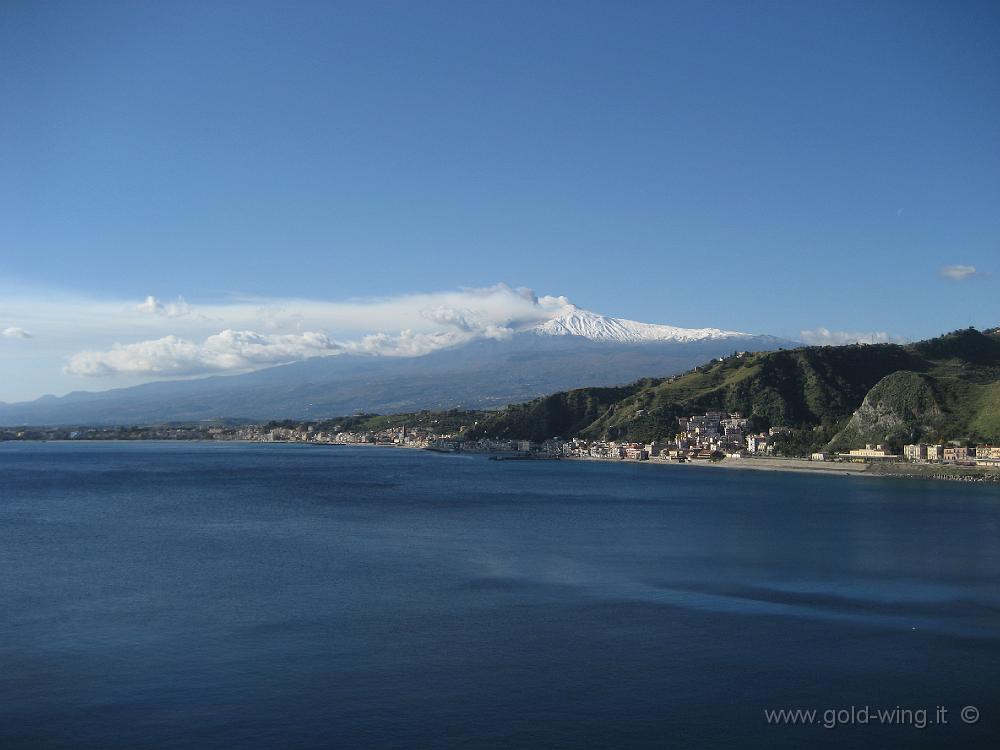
[[7, 411, 1000, 481]]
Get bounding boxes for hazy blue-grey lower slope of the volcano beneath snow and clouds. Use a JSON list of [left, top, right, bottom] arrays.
[[0, 324, 790, 425]]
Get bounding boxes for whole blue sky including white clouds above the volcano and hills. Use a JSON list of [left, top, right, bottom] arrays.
[[0, 0, 1000, 401]]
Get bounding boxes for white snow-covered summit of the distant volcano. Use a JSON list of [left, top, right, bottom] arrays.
[[531, 305, 750, 344]]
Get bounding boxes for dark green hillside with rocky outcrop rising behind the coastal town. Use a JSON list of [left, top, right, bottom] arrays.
[[471, 329, 1000, 454]]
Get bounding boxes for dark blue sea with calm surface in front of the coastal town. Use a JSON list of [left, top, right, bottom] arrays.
[[0, 443, 1000, 750]]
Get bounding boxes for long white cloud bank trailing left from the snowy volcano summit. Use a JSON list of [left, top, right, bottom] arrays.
[[58, 284, 570, 377]]
